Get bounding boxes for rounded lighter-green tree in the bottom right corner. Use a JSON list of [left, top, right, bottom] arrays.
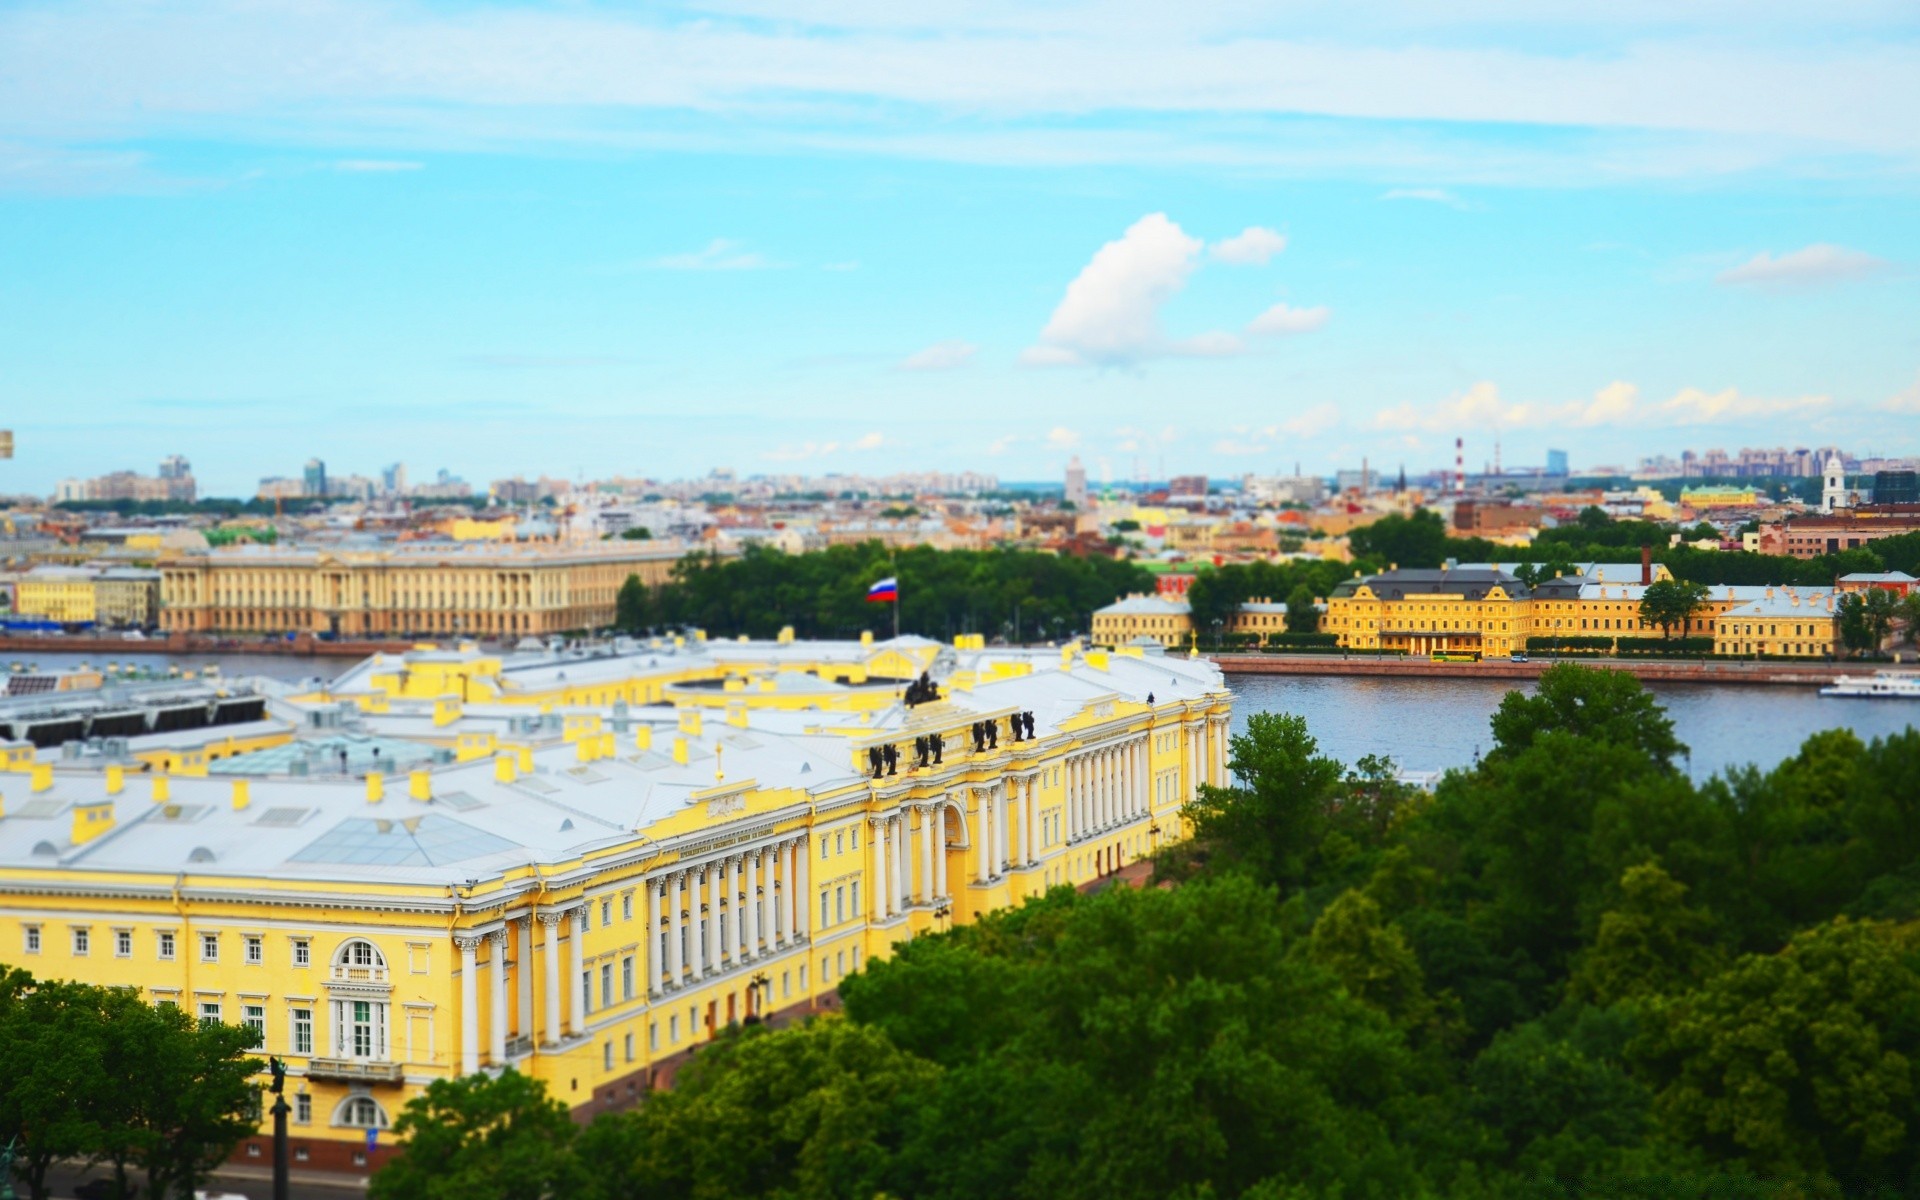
[[1630, 920, 1920, 1194]]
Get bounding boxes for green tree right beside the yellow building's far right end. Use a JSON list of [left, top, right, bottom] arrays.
[[1185, 712, 1346, 885]]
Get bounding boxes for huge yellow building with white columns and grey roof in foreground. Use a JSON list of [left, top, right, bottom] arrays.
[[0, 637, 1231, 1169]]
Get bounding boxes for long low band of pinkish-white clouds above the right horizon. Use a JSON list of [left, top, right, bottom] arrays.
[[1373, 380, 1832, 434]]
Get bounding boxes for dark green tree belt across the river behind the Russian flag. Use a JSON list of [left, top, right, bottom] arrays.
[[616, 541, 1154, 641]]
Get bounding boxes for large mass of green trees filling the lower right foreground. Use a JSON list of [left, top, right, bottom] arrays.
[[372, 666, 1920, 1200]]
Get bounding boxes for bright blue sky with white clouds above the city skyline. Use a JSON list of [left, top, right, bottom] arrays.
[[0, 0, 1920, 495]]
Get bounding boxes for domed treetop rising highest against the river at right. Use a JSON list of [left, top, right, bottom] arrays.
[[1492, 662, 1686, 766]]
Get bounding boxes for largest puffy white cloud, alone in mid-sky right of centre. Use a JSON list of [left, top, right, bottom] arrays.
[[1020, 213, 1240, 367]]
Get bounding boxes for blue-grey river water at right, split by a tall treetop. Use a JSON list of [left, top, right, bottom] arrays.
[[1227, 676, 1920, 780]]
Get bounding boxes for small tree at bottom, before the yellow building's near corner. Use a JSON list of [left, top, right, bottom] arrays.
[[367, 1068, 584, 1200]]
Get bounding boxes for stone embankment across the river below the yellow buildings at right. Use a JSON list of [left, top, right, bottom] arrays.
[[1208, 655, 1885, 687]]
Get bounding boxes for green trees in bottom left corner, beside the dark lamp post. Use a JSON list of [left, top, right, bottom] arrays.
[[0, 966, 263, 1200]]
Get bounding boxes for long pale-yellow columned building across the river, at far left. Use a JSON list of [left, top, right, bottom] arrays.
[[159, 541, 698, 637]]
